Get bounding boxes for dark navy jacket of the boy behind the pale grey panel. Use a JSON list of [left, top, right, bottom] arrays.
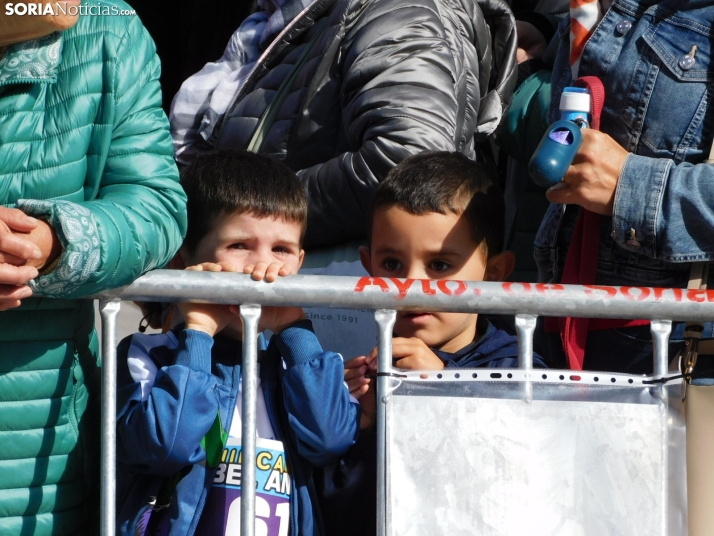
[[316, 315, 546, 536]]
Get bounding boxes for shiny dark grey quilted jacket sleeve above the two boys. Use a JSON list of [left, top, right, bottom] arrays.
[[299, 1, 468, 246]]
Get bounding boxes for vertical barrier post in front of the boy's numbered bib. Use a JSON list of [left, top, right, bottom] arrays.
[[240, 304, 260, 536]]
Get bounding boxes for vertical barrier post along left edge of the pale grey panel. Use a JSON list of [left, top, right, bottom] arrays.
[[374, 309, 397, 536]]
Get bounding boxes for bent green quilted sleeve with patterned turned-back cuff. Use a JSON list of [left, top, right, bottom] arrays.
[[18, 13, 186, 298]]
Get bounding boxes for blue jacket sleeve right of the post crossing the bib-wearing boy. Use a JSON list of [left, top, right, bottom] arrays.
[[276, 320, 359, 466]]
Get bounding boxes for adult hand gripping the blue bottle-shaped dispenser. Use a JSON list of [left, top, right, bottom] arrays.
[[546, 129, 630, 216]]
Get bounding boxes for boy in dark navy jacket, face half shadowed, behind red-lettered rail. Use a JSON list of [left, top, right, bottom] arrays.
[[321, 152, 545, 536]]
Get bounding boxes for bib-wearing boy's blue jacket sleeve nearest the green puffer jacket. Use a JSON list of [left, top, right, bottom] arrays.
[[117, 330, 219, 476]]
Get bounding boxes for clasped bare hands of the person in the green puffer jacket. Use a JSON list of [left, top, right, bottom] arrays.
[[0, 207, 42, 311]]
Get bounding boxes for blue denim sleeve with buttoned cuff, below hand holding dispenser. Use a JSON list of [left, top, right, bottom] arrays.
[[612, 154, 714, 262]]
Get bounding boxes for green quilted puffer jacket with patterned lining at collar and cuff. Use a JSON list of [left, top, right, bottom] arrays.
[[0, 0, 186, 536]]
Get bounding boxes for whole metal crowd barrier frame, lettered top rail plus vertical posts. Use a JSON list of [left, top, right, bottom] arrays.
[[94, 270, 714, 536]]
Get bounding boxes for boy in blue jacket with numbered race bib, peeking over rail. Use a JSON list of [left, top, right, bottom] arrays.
[[117, 151, 359, 536]]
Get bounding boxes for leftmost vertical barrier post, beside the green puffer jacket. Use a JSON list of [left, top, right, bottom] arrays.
[[99, 300, 121, 536]]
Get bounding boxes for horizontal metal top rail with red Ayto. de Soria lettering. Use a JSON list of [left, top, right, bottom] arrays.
[[89, 270, 714, 321]]
